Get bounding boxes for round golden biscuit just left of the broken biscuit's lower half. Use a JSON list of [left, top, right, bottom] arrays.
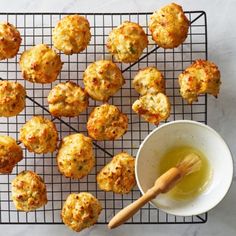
[[87, 103, 128, 140]]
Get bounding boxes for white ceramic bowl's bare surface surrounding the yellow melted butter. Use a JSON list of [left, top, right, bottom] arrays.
[[135, 120, 233, 216]]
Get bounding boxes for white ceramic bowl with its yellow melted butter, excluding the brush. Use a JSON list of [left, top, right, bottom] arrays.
[[135, 120, 233, 216]]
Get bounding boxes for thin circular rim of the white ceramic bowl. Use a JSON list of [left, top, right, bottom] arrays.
[[135, 120, 234, 216]]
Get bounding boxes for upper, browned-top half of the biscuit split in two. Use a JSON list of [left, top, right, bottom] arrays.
[[133, 67, 165, 95]]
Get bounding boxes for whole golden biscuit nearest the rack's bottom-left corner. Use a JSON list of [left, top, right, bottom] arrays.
[[12, 170, 48, 212]]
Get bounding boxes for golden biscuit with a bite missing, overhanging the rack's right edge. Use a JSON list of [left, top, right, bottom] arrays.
[[179, 59, 221, 103]]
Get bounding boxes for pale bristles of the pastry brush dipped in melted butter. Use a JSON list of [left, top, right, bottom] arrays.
[[176, 153, 202, 175]]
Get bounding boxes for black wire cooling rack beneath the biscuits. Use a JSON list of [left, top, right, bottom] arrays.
[[0, 11, 207, 224]]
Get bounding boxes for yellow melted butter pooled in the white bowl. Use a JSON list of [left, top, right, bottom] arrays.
[[158, 146, 211, 200]]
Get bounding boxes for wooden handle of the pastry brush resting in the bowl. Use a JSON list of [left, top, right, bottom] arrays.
[[108, 167, 181, 229]]
